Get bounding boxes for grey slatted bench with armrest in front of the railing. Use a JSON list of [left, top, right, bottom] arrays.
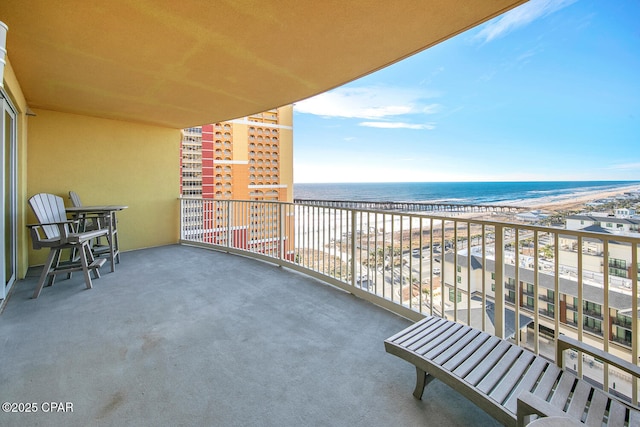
[[384, 316, 640, 426]]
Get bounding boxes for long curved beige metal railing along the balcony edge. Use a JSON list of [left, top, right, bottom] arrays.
[[181, 198, 640, 403]]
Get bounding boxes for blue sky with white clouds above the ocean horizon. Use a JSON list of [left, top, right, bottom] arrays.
[[294, 0, 640, 183]]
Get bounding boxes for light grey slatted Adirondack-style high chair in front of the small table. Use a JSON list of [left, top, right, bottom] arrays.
[[27, 193, 108, 298]]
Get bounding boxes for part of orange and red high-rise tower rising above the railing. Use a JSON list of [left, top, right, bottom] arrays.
[[181, 105, 293, 202]]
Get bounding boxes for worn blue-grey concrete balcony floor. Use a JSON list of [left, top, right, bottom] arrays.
[[0, 245, 498, 427]]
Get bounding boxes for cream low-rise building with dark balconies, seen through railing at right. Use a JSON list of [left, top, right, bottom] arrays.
[[442, 253, 640, 356]]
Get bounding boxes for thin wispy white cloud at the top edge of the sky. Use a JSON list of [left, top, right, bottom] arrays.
[[475, 0, 577, 42]]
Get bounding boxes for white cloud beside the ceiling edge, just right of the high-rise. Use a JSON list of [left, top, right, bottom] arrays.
[[294, 87, 438, 120]]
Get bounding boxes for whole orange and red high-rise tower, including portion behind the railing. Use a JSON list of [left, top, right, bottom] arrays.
[[180, 105, 293, 257]]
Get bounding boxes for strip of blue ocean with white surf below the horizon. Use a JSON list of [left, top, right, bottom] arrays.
[[293, 181, 640, 205]]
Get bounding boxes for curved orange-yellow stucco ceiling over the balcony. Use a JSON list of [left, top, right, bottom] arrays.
[[0, 0, 524, 128]]
